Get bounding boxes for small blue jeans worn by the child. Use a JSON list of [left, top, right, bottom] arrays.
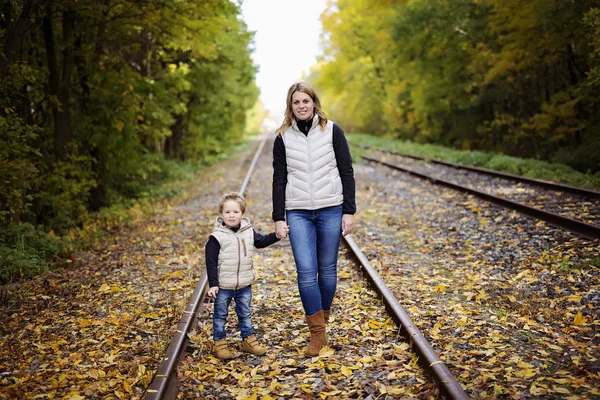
[[213, 286, 254, 342]]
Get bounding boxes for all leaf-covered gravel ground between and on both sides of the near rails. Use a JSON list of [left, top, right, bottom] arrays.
[[0, 136, 600, 399]]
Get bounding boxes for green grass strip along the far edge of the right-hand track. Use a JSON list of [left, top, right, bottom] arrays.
[[346, 133, 600, 191]]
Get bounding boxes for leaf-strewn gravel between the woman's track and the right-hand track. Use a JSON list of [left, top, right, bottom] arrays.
[[353, 164, 600, 399]]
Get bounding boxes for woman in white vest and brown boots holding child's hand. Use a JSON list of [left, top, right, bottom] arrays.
[[273, 82, 356, 357]]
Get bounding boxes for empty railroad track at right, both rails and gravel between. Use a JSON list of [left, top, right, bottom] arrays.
[[362, 147, 600, 239]]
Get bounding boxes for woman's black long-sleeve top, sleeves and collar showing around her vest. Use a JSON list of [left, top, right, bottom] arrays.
[[273, 119, 356, 222]]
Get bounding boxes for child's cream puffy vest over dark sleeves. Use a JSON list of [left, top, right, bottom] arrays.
[[212, 216, 254, 290]]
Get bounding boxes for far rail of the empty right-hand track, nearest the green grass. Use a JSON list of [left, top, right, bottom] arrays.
[[359, 145, 600, 199]]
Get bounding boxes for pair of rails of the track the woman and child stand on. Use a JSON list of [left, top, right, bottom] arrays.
[[146, 139, 469, 400]]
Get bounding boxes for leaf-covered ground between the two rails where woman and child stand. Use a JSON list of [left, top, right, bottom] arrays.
[[179, 142, 439, 399]]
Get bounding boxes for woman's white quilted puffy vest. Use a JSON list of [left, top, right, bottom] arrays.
[[281, 115, 344, 210]]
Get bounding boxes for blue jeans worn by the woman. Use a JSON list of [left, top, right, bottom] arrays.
[[286, 205, 342, 315]]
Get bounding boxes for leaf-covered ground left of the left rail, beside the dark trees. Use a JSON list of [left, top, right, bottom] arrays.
[[0, 140, 256, 399]]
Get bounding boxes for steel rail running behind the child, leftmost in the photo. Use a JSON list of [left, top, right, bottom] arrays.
[[145, 135, 267, 400]]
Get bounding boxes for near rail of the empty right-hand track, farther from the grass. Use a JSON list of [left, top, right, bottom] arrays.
[[362, 155, 600, 240]]
